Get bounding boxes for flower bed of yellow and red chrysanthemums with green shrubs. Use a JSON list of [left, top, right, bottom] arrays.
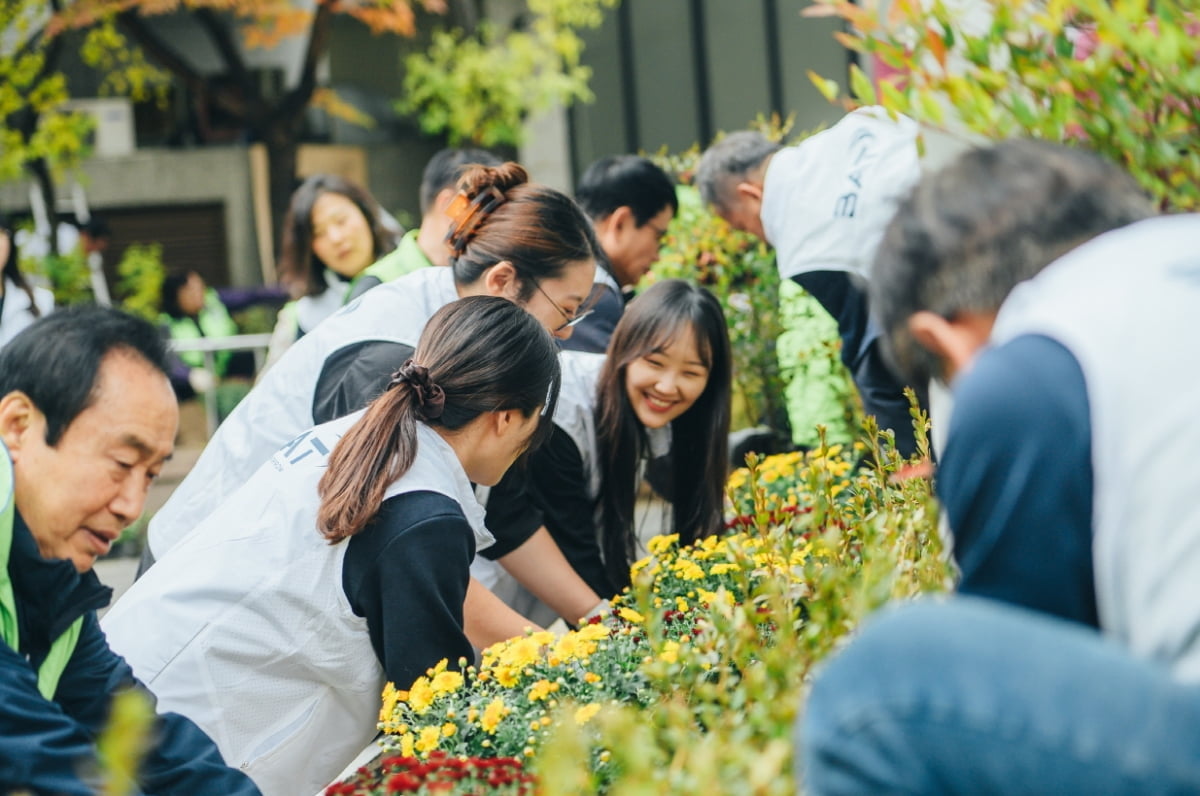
[[330, 429, 949, 795]]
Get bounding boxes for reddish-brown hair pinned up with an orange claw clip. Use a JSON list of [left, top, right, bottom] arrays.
[[446, 163, 600, 301]]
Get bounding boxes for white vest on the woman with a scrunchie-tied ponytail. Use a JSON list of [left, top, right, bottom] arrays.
[[102, 412, 492, 796]]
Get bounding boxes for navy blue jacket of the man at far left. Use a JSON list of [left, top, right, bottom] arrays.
[[0, 515, 259, 796]]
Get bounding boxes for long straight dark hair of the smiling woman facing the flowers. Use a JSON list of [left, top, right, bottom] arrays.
[[596, 280, 732, 588]]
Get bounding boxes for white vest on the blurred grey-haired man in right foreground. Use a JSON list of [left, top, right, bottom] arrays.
[[992, 215, 1200, 682]]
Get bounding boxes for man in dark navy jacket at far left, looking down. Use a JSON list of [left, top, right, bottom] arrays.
[[0, 307, 258, 795]]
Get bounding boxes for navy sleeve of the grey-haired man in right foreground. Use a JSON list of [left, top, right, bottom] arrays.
[[937, 336, 1098, 627]]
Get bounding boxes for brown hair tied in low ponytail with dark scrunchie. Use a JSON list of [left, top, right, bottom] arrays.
[[317, 297, 559, 544]]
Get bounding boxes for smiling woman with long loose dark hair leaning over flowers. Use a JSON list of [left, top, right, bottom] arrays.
[[487, 280, 731, 620]]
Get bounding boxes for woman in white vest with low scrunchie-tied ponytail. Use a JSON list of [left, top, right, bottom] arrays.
[[103, 297, 559, 796]]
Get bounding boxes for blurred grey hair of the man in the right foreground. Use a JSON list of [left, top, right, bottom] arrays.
[[870, 139, 1154, 384]]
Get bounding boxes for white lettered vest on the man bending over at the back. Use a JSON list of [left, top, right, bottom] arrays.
[[760, 107, 920, 279]]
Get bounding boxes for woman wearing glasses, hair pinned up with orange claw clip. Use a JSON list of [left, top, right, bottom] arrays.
[[144, 163, 609, 646]]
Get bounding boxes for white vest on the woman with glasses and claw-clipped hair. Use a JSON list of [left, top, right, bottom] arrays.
[[149, 268, 458, 558]]
